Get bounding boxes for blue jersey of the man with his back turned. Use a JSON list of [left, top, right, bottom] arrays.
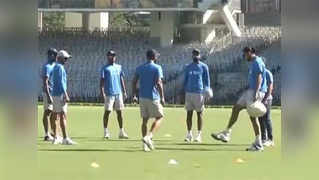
[[136, 62, 162, 100]]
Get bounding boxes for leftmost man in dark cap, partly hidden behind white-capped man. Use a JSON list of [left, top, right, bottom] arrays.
[[42, 48, 58, 141]]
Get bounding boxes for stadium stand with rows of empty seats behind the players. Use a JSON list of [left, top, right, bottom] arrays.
[[38, 24, 281, 104]]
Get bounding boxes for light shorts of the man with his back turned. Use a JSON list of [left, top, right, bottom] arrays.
[[140, 98, 164, 118]]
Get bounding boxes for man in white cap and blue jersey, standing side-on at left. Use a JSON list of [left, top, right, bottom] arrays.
[[52, 50, 76, 145]]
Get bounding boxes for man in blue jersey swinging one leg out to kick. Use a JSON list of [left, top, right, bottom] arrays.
[[211, 47, 267, 151]]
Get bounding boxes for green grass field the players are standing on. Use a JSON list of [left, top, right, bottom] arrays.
[[37, 106, 281, 180]]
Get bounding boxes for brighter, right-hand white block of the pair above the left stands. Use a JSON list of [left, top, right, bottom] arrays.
[[88, 12, 109, 31]]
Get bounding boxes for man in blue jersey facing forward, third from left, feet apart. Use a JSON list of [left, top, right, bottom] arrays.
[[100, 50, 128, 139]]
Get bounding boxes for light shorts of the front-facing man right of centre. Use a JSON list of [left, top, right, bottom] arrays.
[[185, 93, 205, 112]]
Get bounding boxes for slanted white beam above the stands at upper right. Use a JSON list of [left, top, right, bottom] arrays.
[[220, 5, 241, 37]]
